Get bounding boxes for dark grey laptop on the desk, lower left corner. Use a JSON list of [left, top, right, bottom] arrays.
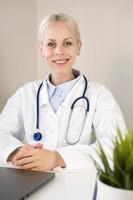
[[0, 167, 55, 200]]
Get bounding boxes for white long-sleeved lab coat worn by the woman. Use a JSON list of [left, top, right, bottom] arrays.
[[0, 76, 126, 170]]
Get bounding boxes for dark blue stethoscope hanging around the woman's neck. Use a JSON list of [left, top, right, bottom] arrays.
[[33, 75, 89, 145]]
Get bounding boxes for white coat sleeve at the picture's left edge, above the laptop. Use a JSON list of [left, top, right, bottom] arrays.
[[0, 90, 24, 162]]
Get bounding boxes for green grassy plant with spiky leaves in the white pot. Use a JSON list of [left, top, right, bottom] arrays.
[[93, 129, 133, 190]]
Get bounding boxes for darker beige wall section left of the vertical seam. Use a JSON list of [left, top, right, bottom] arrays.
[[0, 0, 37, 111]]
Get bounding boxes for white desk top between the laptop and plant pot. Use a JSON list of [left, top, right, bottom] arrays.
[[0, 164, 95, 200]]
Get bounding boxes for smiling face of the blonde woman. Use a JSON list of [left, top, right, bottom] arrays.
[[40, 22, 81, 74]]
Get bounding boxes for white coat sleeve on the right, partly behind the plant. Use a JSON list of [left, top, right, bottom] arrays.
[[57, 87, 127, 171]]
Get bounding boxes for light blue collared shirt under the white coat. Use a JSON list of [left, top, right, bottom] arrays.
[[46, 76, 80, 113]]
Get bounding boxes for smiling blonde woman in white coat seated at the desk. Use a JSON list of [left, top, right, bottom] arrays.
[[0, 14, 126, 171]]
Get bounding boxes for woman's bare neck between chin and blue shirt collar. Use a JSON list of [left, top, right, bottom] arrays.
[[51, 71, 75, 85]]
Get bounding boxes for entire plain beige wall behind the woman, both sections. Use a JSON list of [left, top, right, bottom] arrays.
[[0, 0, 133, 127]]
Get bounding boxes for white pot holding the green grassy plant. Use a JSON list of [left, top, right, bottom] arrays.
[[97, 177, 133, 200]]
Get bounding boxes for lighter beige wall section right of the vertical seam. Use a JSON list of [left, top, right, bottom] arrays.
[[37, 0, 133, 127]]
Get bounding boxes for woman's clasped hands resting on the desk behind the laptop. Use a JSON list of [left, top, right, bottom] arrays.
[[10, 144, 65, 171]]
